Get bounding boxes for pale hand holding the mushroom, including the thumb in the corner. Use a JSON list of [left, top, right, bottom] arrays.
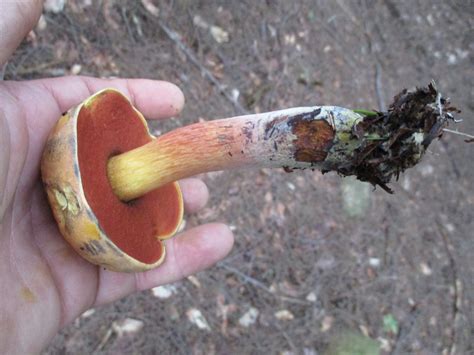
[[0, 1, 233, 354]]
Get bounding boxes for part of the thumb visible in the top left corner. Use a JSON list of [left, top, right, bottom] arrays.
[[0, 0, 43, 67]]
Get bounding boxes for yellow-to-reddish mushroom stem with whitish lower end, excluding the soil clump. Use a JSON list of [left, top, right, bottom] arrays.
[[108, 106, 352, 201]]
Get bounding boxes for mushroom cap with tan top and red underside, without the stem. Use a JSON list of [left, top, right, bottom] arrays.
[[41, 89, 183, 272]]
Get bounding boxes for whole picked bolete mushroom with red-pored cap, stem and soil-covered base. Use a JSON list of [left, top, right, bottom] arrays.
[[42, 83, 456, 271]]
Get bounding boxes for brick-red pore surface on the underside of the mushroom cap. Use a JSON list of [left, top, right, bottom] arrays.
[[77, 91, 181, 264]]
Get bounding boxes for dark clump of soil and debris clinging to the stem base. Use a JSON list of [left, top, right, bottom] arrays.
[[338, 82, 460, 193]]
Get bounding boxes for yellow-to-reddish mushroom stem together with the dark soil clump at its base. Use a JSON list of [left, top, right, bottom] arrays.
[[108, 84, 455, 201]]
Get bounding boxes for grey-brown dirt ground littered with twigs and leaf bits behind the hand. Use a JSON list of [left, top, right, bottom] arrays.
[[5, 0, 474, 355]]
